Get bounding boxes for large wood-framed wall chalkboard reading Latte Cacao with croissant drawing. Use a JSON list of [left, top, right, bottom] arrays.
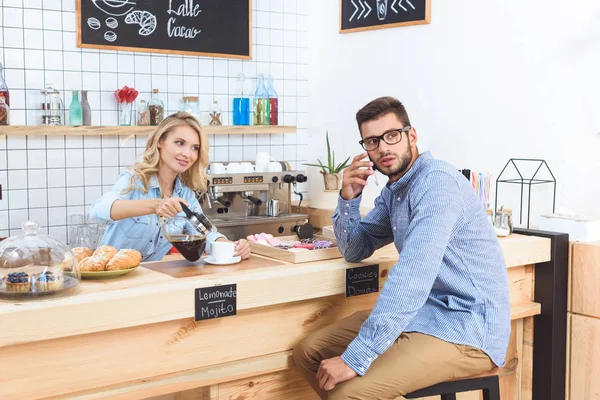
[[77, 0, 252, 59]]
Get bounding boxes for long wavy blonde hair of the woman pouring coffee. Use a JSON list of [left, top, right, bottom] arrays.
[[125, 112, 208, 193]]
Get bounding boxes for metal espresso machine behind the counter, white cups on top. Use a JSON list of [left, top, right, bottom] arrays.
[[198, 161, 308, 240]]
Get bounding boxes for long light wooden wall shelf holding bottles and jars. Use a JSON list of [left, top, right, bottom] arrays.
[[0, 125, 296, 136]]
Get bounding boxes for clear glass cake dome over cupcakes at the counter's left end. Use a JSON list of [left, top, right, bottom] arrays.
[[0, 221, 81, 297]]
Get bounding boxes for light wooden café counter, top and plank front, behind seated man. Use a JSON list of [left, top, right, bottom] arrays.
[[0, 235, 551, 399]]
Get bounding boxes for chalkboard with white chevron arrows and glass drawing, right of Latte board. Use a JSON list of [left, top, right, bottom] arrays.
[[340, 0, 431, 33]]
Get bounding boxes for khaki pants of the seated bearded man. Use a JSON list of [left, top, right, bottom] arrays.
[[294, 311, 494, 400]]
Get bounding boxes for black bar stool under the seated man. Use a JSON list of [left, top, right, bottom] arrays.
[[404, 368, 501, 400]]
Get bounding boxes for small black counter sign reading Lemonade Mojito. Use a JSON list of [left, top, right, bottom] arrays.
[[194, 283, 237, 321]]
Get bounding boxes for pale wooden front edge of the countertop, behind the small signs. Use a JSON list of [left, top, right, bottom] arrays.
[[0, 235, 550, 347]]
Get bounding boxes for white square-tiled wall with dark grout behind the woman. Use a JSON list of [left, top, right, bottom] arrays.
[[0, 0, 308, 240]]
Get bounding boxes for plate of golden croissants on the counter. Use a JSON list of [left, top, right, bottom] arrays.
[[71, 246, 142, 279]]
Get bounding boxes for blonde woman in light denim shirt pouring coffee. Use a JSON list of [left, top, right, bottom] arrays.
[[90, 112, 250, 261]]
